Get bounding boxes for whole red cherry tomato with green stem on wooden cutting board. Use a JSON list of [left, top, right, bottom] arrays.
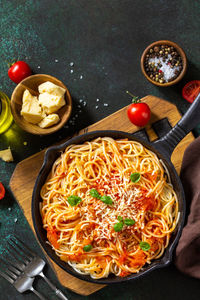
[[127, 102, 151, 127]]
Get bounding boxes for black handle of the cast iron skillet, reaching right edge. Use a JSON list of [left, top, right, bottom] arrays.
[[153, 93, 200, 158]]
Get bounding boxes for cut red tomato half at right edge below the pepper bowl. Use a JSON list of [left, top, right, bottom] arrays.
[[182, 80, 200, 103]]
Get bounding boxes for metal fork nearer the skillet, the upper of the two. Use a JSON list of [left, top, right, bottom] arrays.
[[7, 236, 68, 300]]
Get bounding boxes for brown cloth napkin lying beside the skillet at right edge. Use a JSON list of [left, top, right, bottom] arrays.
[[175, 137, 200, 279]]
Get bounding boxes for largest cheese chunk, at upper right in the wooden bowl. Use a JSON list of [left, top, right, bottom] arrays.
[[39, 92, 65, 114]]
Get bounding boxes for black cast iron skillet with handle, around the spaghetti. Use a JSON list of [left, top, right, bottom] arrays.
[[32, 94, 200, 284]]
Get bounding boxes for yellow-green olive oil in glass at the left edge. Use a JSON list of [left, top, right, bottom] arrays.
[[0, 91, 13, 134]]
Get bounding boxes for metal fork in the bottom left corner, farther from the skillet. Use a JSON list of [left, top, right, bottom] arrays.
[[0, 258, 46, 300]]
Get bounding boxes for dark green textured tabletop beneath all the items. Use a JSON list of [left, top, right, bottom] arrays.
[[0, 0, 200, 300]]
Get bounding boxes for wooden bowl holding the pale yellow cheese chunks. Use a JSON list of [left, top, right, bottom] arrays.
[[11, 74, 72, 135]]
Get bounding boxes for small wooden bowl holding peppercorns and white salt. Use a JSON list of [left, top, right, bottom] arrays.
[[140, 40, 187, 87]]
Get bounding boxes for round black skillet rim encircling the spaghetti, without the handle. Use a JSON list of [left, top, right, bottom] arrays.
[[31, 130, 186, 284]]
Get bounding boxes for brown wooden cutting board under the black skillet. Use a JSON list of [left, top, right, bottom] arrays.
[[10, 96, 194, 296]]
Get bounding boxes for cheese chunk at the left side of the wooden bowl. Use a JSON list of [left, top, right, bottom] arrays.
[[21, 90, 44, 124]]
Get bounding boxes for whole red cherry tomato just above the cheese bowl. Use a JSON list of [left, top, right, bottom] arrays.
[[8, 61, 31, 83]]
